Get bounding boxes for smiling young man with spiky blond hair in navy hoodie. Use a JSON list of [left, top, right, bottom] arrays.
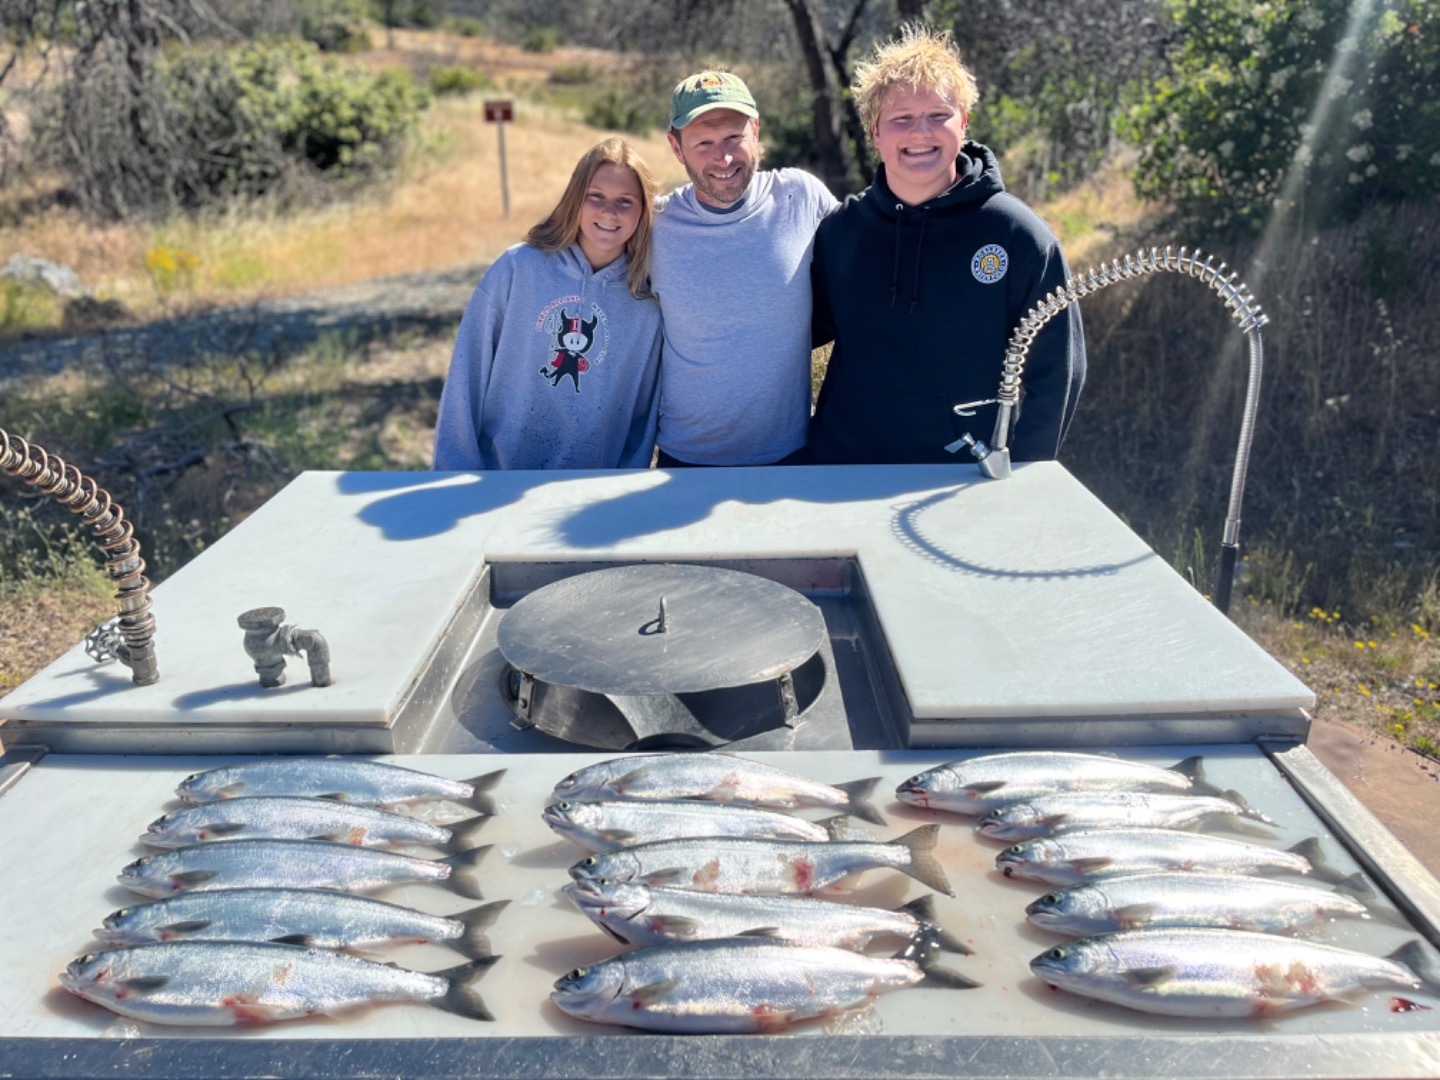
[[809, 27, 1086, 464]]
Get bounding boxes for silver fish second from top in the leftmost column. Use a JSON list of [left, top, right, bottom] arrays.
[[140, 795, 490, 852]]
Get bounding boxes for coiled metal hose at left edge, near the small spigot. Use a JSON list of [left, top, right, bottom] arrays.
[[0, 428, 160, 687]]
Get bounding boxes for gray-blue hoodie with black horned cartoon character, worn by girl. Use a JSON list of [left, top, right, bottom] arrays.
[[435, 243, 661, 469]]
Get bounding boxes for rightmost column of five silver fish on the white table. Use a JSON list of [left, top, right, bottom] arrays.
[[897, 752, 1440, 1018]]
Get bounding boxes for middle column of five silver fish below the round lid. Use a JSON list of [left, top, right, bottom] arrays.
[[543, 753, 975, 1034]]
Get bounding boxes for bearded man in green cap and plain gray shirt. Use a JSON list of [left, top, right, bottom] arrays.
[[651, 71, 837, 468]]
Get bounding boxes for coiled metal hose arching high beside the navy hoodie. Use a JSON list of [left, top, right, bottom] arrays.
[[991, 246, 1270, 612]]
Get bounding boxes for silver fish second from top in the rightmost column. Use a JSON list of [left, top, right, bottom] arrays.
[[975, 791, 1274, 840]]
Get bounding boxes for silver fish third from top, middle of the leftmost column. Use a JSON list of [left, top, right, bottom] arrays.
[[120, 840, 490, 900]]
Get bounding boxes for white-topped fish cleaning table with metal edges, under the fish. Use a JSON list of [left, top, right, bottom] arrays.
[[0, 462, 1440, 1077]]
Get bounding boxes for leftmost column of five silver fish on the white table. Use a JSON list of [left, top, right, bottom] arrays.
[[60, 759, 507, 1025]]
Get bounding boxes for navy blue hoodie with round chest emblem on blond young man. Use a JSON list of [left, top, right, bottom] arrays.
[[809, 143, 1086, 465]]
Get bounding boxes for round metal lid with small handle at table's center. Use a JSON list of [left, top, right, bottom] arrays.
[[498, 563, 825, 694]]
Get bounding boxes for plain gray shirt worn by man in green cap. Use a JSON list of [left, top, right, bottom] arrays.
[[651, 168, 837, 465]]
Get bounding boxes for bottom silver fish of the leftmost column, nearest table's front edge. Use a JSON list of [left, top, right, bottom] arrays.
[[60, 942, 495, 1025]]
